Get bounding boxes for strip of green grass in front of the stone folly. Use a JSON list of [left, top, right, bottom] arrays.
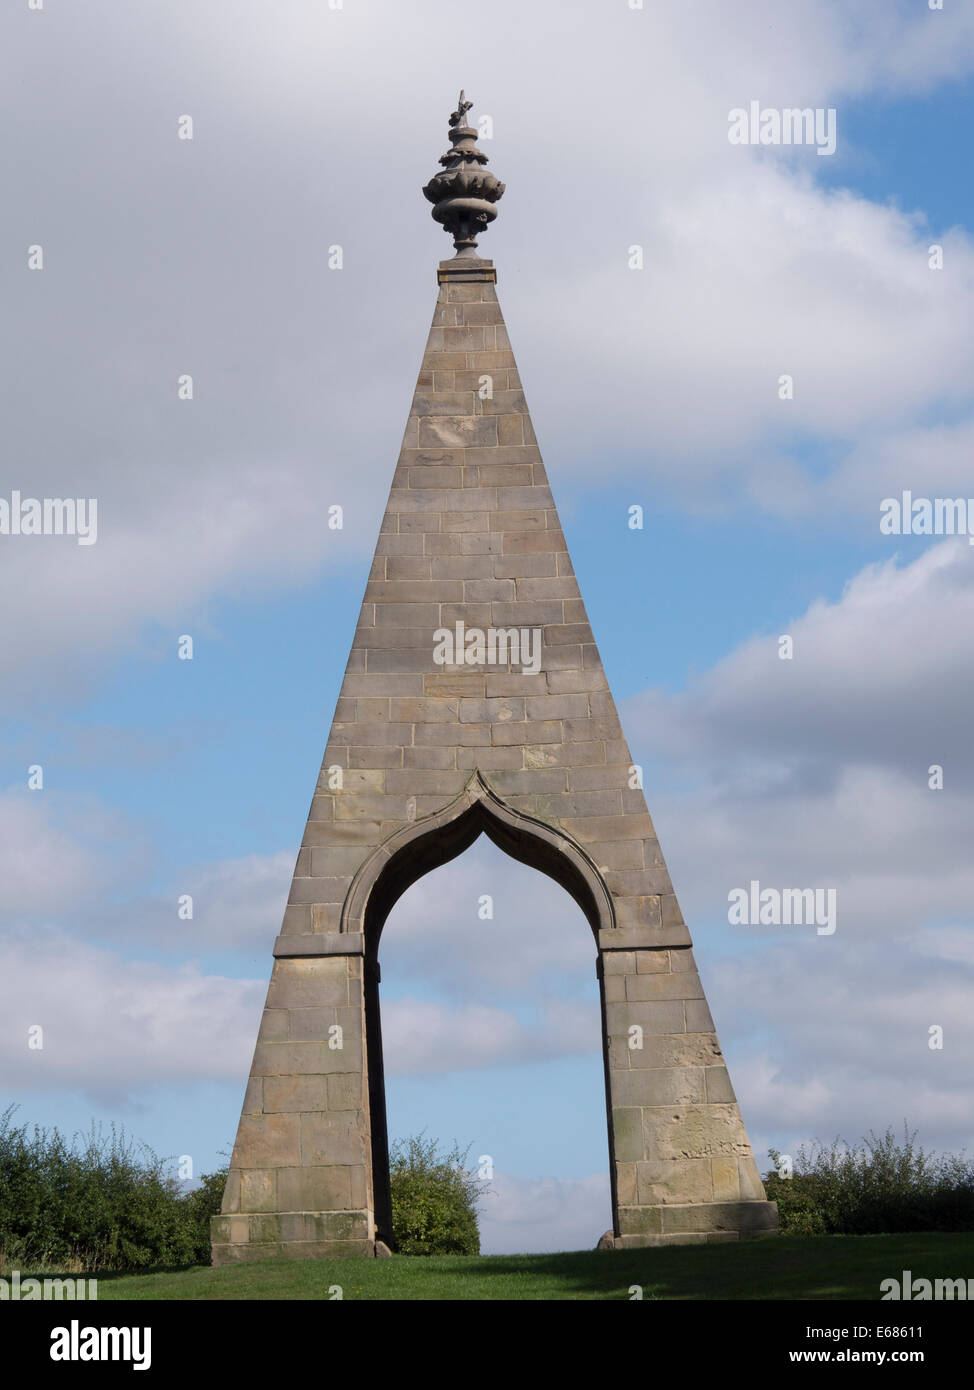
[[79, 1232, 974, 1301]]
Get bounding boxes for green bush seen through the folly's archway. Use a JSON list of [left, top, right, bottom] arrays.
[[389, 1134, 484, 1255]]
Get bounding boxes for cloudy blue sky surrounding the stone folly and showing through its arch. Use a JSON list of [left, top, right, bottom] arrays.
[[0, 0, 974, 1248]]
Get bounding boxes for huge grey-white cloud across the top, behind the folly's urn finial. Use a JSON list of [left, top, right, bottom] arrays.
[[0, 0, 974, 699]]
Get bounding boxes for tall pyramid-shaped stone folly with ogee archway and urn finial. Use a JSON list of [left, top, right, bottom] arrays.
[[213, 93, 777, 1264]]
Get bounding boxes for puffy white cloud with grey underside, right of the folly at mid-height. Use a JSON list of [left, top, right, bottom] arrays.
[[628, 538, 974, 792]]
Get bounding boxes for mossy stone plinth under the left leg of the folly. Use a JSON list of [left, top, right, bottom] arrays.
[[210, 1211, 377, 1265]]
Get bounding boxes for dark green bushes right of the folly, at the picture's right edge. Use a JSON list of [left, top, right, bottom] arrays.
[[764, 1125, 974, 1236]]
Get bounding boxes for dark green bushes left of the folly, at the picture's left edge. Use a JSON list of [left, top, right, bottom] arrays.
[[0, 1105, 225, 1273]]
